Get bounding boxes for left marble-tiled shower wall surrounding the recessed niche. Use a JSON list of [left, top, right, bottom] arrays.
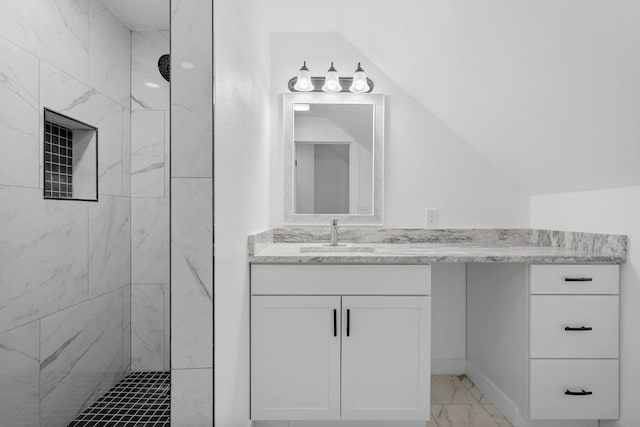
[[0, 0, 131, 426]]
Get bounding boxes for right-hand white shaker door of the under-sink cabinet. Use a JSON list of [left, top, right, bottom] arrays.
[[342, 296, 431, 420]]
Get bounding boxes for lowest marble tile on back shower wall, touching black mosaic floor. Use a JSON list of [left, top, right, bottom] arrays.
[[131, 285, 165, 371]]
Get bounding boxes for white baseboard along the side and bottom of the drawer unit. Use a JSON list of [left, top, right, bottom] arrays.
[[466, 360, 600, 427]]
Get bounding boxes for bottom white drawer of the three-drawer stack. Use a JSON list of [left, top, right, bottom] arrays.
[[529, 359, 619, 420]]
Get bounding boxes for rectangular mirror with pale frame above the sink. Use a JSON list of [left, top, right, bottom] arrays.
[[283, 93, 384, 225]]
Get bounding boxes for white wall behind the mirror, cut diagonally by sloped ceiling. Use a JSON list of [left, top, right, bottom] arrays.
[[270, 33, 529, 227]]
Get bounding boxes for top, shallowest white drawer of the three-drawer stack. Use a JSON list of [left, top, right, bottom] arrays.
[[530, 264, 620, 294]]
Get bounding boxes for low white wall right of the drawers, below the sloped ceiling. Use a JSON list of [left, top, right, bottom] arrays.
[[531, 186, 640, 427]]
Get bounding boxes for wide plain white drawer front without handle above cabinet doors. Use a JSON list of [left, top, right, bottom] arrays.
[[251, 264, 431, 295]]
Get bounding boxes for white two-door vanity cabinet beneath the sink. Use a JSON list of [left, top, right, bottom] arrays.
[[251, 265, 431, 420]]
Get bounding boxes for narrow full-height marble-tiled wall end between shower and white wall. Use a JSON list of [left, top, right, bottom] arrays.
[[171, 0, 213, 425]]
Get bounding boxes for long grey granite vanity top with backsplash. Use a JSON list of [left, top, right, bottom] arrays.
[[249, 227, 627, 264]]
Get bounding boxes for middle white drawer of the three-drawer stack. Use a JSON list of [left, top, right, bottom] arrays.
[[530, 295, 619, 359]]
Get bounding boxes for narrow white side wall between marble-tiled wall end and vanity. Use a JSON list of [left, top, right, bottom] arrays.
[[214, 0, 270, 427]]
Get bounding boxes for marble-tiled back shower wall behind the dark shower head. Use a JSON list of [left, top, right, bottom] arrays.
[[130, 31, 170, 371]]
